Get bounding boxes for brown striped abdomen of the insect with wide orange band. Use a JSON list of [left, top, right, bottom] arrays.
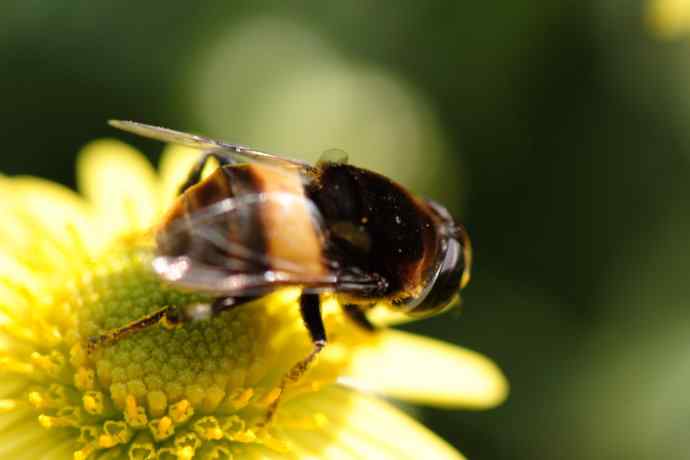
[[158, 164, 323, 275]]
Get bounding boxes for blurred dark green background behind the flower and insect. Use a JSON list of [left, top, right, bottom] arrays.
[[0, 0, 690, 460]]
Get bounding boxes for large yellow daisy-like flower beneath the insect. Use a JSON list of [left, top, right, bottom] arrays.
[[0, 140, 507, 460]]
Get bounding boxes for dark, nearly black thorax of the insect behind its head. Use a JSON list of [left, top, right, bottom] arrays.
[[307, 163, 438, 303]]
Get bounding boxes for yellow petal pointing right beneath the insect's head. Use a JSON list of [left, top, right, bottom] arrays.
[[345, 330, 508, 409]]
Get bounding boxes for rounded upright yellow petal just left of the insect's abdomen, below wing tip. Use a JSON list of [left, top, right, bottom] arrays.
[[77, 140, 159, 236]]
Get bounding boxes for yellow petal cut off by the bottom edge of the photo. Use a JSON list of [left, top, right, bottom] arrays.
[[278, 385, 463, 460]]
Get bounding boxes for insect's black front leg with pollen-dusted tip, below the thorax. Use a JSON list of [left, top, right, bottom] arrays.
[[264, 293, 327, 424]]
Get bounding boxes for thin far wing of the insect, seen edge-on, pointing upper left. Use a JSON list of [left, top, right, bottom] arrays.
[[108, 120, 312, 168]]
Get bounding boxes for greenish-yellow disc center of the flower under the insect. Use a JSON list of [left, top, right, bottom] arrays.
[[13, 240, 354, 460]]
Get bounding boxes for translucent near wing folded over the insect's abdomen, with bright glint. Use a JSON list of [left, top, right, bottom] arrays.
[[153, 193, 338, 296]]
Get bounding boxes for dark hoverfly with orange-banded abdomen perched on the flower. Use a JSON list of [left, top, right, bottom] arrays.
[[90, 121, 471, 417]]
